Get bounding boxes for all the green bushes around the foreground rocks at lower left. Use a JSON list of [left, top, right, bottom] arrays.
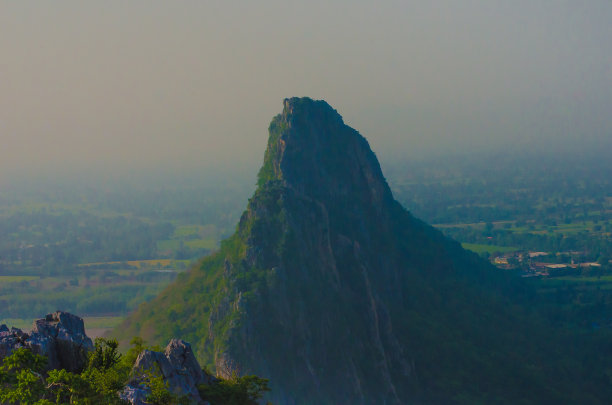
[[0, 338, 269, 405]]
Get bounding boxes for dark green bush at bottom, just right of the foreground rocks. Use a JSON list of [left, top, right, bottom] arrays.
[[198, 374, 270, 405]]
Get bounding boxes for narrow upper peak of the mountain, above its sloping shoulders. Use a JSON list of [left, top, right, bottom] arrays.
[[259, 97, 392, 215]]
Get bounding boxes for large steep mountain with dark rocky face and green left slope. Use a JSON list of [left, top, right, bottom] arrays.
[[118, 98, 610, 404]]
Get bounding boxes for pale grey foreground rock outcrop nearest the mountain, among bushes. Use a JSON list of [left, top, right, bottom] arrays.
[[121, 339, 216, 405]]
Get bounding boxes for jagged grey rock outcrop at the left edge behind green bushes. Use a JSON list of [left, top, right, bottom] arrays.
[[0, 311, 93, 372]]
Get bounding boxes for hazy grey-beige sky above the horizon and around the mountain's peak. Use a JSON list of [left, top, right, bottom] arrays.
[[0, 0, 612, 180]]
